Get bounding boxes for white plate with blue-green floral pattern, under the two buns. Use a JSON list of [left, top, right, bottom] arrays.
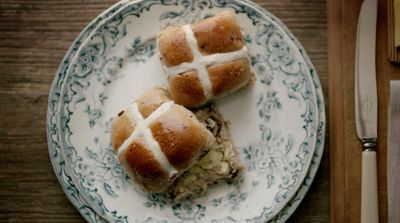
[[47, 0, 325, 222]]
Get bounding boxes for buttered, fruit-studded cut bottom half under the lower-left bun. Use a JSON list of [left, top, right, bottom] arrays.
[[169, 106, 243, 200]]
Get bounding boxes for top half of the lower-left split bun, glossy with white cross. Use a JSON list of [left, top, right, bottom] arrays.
[[111, 87, 216, 192]]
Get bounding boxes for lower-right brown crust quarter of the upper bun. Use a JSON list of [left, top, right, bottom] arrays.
[[207, 59, 252, 97]]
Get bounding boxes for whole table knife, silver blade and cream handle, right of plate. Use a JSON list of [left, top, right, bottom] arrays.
[[355, 0, 379, 223]]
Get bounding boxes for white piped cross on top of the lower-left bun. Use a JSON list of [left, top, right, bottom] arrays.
[[117, 101, 178, 177]]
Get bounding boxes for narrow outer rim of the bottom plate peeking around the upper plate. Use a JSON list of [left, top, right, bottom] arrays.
[[46, 0, 326, 221]]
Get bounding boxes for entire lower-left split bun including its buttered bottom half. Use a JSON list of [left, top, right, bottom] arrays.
[[111, 87, 243, 200]]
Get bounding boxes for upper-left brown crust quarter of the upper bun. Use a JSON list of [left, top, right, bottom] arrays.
[[157, 26, 193, 67]]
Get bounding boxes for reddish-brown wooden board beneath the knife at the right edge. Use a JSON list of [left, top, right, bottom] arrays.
[[327, 0, 400, 222]]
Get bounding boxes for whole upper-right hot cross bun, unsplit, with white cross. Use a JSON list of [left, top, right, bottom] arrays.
[[157, 11, 254, 107]]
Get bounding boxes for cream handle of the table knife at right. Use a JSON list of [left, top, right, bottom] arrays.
[[361, 150, 379, 223]]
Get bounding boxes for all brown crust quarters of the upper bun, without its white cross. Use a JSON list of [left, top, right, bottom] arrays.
[[158, 11, 253, 108]]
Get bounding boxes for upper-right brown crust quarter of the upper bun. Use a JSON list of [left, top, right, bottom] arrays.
[[191, 11, 243, 55]]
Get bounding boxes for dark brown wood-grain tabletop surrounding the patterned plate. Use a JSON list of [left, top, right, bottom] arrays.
[[0, 0, 330, 222]]
